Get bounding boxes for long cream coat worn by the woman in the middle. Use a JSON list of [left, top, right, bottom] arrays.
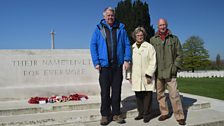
[[131, 41, 156, 91]]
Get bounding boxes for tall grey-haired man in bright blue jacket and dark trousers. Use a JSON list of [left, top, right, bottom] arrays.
[[90, 7, 131, 125]]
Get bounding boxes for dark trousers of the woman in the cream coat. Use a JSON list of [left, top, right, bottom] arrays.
[[135, 91, 152, 116]]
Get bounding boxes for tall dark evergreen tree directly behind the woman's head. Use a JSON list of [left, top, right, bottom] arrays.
[[115, 0, 155, 44]]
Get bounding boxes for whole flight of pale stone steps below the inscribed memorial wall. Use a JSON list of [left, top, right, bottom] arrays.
[[0, 93, 220, 126]]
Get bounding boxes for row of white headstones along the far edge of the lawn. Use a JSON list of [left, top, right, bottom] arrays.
[[177, 71, 224, 78]]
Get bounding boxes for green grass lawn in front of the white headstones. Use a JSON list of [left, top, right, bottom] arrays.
[[177, 78, 224, 100]]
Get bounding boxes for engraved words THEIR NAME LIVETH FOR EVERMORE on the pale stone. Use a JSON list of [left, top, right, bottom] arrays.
[[12, 59, 91, 77]]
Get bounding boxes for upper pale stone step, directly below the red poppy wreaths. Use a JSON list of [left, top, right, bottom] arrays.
[[0, 94, 211, 116]]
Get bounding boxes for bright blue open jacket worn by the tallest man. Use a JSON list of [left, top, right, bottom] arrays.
[[90, 19, 131, 67]]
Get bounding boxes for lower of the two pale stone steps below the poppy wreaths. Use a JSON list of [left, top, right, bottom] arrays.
[[0, 104, 144, 126]]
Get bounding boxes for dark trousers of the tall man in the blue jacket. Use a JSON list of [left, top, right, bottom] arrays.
[[99, 65, 123, 116]]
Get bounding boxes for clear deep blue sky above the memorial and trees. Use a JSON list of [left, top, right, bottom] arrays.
[[0, 0, 224, 60]]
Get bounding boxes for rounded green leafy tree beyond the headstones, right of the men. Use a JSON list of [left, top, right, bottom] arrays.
[[183, 36, 211, 72]]
